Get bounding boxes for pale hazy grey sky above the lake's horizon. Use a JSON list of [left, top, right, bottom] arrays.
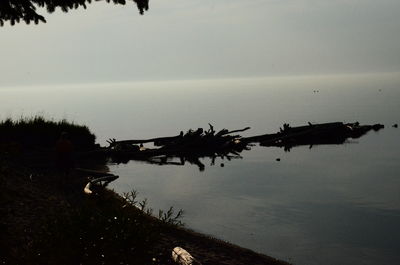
[[0, 0, 400, 86]]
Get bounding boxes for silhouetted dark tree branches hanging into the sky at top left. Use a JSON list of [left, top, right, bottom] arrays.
[[0, 0, 149, 26]]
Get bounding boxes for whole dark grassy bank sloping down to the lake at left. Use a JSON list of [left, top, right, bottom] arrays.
[[0, 117, 286, 264]]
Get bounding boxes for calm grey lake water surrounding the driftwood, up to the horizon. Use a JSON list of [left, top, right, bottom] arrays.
[[0, 73, 400, 265]]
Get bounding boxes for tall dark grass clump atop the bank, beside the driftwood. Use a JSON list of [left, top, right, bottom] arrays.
[[0, 116, 96, 152]]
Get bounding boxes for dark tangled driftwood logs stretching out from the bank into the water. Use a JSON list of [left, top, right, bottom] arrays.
[[94, 122, 384, 170]]
